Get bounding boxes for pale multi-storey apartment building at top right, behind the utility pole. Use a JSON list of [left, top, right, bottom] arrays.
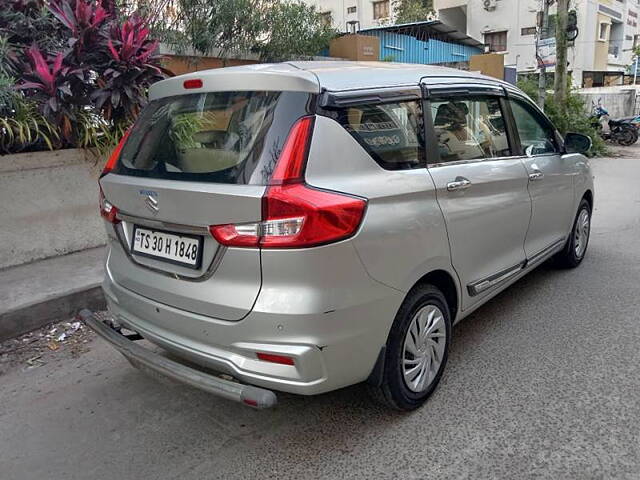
[[434, 0, 640, 86]]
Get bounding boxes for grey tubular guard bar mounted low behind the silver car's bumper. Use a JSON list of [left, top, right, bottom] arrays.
[[80, 310, 277, 409]]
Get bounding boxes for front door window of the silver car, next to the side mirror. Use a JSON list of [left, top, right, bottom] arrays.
[[509, 100, 558, 156]]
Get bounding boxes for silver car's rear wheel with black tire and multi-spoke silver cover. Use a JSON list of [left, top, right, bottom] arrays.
[[371, 285, 451, 411]]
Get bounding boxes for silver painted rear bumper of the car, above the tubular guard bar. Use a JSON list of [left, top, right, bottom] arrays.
[[103, 256, 403, 395]]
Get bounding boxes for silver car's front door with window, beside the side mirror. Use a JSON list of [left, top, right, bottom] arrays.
[[508, 95, 574, 262]]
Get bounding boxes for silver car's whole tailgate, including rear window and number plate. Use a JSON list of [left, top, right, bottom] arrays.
[[100, 91, 311, 320]]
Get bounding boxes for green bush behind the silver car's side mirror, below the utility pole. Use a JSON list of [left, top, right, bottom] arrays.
[[518, 77, 607, 155]]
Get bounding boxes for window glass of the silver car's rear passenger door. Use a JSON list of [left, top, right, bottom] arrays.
[[431, 97, 511, 162]]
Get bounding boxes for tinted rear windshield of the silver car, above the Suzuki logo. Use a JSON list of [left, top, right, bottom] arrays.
[[114, 91, 313, 185]]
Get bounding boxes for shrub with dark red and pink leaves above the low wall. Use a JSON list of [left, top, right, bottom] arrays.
[[0, 0, 167, 152]]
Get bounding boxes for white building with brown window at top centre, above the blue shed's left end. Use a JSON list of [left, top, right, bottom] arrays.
[[304, 0, 394, 32]]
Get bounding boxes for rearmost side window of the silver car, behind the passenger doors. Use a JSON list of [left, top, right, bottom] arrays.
[[324, 101, 425, 170]]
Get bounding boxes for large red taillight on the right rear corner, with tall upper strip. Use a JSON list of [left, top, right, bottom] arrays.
[[209, 117, 367, 248]]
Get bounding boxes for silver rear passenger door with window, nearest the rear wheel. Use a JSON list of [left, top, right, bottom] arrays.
[[425, 88, 531, 309]]
